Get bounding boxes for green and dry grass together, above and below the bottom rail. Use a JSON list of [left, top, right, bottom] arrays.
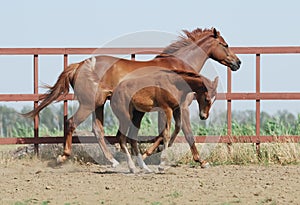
[[0, 106, 300, 166]]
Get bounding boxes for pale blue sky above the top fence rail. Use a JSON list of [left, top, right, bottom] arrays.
[[0, 0, 300, 47]]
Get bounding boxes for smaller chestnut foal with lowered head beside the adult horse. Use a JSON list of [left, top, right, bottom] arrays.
[[110, 67, 218, 173]]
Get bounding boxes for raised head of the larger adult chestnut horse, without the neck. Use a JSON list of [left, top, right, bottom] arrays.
[[209, 28, 241, 71]]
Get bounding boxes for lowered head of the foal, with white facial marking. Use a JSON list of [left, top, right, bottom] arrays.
[[196, 77, 219, 120]]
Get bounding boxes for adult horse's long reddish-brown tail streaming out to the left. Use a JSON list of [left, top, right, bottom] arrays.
[[22, 63, 82, 117]]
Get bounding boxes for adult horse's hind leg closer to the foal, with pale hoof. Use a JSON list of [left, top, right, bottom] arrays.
[[93, 105, 119, 167]]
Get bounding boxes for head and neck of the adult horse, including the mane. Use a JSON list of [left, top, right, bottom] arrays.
[[158, 28, 241, 72]]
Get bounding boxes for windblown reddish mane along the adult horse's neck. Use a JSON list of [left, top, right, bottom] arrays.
[[159, 28, 214, 56]]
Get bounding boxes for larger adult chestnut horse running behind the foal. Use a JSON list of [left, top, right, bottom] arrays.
[[23, 28, 241, 166]]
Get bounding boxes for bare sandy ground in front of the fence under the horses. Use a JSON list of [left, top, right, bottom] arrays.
[[0, 159, 300, 205]]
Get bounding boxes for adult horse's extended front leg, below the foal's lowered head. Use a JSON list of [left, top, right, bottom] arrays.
[[181, 93, 208, 168]]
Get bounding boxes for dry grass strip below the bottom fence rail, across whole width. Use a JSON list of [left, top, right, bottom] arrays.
[[0, 143, 300, 166]]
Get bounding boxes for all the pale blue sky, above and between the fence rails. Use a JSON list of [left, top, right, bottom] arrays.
[[0, 0, 300, 113]]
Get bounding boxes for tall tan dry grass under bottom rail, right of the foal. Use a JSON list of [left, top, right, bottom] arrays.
[[180, 143, 300, 165]]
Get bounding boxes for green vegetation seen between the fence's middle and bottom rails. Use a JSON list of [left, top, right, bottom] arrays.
[[0, 106, 300, 137]]
